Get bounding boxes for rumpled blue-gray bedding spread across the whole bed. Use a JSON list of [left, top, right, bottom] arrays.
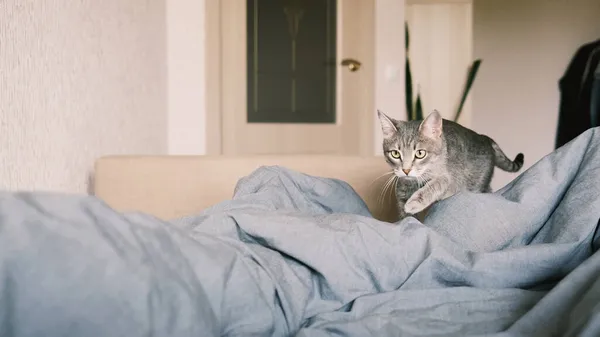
[[0, 128, 600, 337]]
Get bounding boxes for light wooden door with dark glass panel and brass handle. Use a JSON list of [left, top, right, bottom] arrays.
[[220, 0, 375, 155]]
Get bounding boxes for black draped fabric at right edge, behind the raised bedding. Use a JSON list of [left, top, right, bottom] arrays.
[[555, 40, 600, 148]]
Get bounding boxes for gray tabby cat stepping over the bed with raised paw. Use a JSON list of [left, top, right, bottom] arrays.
[[377, 110, 524, 219]]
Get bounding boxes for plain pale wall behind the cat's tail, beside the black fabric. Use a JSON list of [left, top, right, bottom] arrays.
[[473, 0, 600, 188]]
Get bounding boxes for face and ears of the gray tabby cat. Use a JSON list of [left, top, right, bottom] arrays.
[[378, 111, 445, 180]]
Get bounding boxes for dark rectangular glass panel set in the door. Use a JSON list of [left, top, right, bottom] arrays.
[[247, 0, 337, 123]]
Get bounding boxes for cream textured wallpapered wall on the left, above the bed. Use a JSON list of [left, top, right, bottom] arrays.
[[0, 0, 167, 193]]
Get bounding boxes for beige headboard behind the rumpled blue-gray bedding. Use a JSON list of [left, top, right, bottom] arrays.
[[94, 155, 396, 221]]
